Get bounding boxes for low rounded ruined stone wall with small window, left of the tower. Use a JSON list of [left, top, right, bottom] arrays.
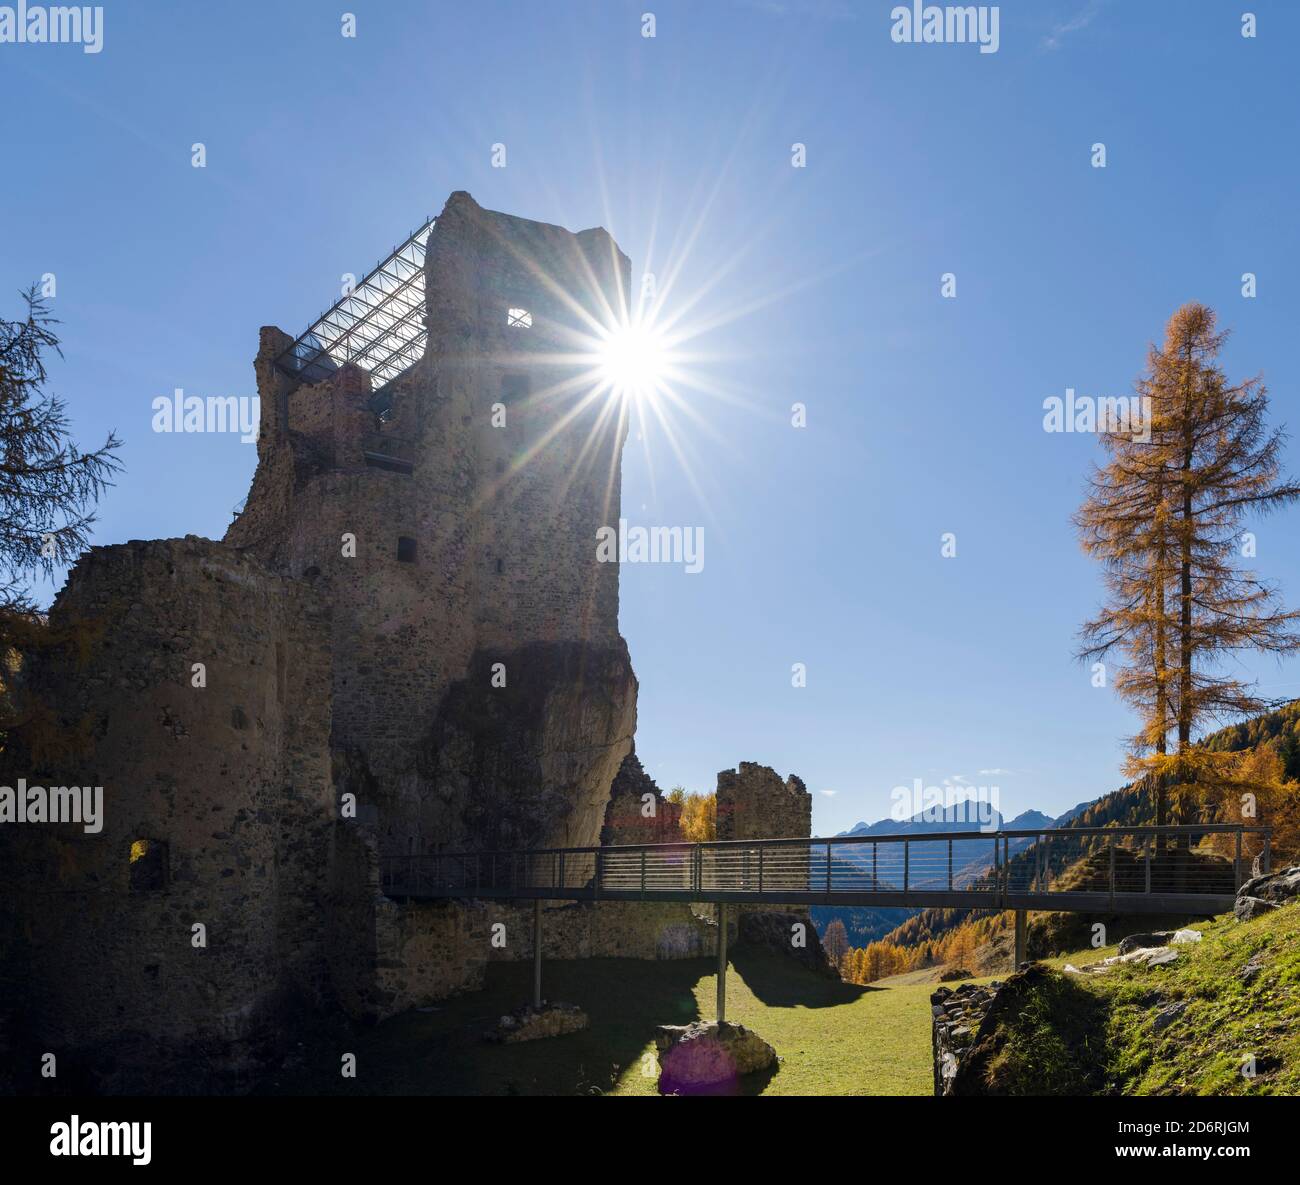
[[0, 537, 333, 1090]]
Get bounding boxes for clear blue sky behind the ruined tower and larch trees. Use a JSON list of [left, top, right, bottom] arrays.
[[0, 0, 1300, 833]]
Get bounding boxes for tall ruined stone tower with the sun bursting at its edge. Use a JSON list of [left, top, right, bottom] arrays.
[[226, 192, 636, 854]]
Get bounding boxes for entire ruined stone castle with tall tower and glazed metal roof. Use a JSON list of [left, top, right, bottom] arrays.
[[0, 192, 810, 1091]]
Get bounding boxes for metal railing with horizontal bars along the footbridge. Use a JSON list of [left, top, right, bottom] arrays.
[[381, 824, 1271, 907]]
